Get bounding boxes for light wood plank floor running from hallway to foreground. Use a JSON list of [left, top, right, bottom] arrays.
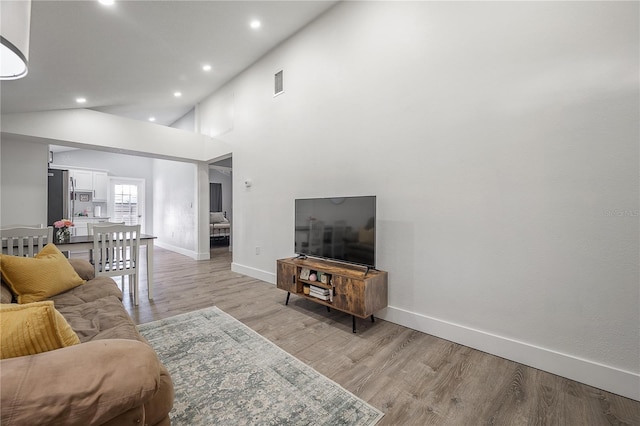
[[116, 247, 640, 426]]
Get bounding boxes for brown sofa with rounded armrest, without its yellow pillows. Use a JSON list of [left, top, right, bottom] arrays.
[[0, 259, 174, 426]]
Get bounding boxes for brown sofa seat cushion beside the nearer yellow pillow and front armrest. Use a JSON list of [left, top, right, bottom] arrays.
[[58, 296, 144, 343]]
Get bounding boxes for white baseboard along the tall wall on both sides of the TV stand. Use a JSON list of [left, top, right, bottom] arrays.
[[231, 263, 640, 401]]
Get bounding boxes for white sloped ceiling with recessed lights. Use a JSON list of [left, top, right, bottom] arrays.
[[0, 0, 336, 125]]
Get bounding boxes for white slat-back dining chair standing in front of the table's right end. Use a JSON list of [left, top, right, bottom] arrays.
[[93, 225, 140, 306]]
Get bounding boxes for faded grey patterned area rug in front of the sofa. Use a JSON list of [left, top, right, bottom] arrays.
[[138, 307, 384, 426]]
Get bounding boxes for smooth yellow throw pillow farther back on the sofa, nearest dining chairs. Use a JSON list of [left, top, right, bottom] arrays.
[[0, 243, 84, 303]]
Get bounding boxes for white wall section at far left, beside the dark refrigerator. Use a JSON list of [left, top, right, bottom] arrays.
[[0, 137, 49, 226]]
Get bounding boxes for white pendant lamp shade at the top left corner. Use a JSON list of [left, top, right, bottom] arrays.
[[0, 0, 31, 80]]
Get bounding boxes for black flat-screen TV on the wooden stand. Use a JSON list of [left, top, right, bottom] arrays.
[[295, 196, 376, 268]]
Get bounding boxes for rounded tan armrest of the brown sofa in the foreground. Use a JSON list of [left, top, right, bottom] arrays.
[[0, 339, 161, 426]]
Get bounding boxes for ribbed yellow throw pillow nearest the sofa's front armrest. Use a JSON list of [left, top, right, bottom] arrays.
[[0, 301, 80, 359]]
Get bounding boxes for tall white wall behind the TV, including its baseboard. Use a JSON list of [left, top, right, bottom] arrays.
[[196, 2, 640, 399]]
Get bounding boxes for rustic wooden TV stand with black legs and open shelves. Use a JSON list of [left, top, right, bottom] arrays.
[[277, 257, 388, 333]]
